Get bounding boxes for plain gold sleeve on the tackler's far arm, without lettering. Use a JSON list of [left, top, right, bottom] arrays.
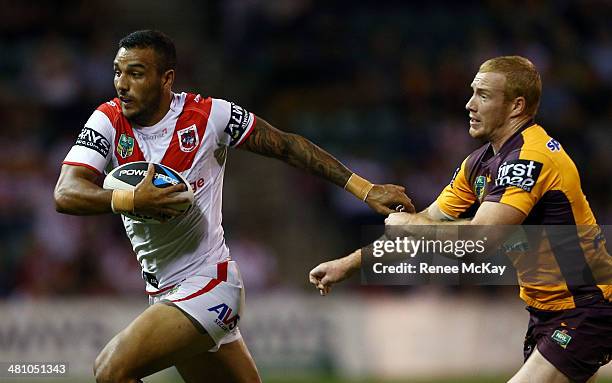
[[436, 158, 478, 218]]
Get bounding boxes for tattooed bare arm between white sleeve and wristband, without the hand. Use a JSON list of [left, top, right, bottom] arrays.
[[243, 119, 352, 187]]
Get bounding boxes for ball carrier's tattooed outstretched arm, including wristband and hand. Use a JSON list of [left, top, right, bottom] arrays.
[[240, 117, 414, 215]]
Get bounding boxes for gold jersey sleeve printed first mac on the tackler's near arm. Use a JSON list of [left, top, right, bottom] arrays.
[[484, 150, 560, 215]]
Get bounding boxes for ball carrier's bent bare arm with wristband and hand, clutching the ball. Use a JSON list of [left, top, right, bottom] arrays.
[[53, 164, 188, 220]]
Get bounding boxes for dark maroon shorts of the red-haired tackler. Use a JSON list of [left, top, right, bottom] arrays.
[[523, 302, 612, 382]]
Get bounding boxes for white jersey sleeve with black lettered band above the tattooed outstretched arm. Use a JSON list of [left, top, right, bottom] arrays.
[[211, 99, 257, 148]]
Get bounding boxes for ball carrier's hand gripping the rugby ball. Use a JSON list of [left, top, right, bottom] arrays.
[[134, 164, 189, 222]]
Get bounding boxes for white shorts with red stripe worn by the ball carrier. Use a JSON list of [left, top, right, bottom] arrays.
[[149, 261, 244, 352]]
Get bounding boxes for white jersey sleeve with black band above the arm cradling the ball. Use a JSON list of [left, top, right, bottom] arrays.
[[63, 110, 114, 173]]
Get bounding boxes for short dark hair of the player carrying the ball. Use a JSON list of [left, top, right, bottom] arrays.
[[119, 29, 176, 72]]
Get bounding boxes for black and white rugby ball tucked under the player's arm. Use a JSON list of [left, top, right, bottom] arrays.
[[103, 161, 193, 223]]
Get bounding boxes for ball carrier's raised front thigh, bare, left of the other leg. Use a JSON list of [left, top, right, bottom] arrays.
[[96, 304, 214, 378]]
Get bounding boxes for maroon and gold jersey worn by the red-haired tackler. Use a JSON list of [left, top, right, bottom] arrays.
[[437, 123, 612, 310]]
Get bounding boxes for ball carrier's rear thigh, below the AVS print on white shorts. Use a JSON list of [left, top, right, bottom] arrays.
[[176, 338, 261, 383]]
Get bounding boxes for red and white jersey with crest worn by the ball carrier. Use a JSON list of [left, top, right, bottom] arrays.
[[63, 93, 256, 291]]
